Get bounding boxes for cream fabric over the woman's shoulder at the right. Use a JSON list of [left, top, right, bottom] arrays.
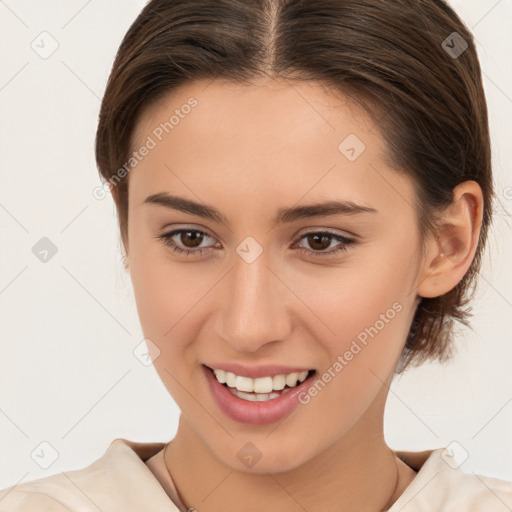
[[389, 448, 512, 512]]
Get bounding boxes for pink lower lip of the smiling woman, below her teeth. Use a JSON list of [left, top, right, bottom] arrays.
[[203, 365, 315, 425]]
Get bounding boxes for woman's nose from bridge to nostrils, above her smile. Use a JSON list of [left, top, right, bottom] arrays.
[[213, 251, 293, 352]]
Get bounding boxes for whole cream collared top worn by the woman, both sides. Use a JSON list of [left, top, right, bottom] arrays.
[[0, 438, 512, 512]]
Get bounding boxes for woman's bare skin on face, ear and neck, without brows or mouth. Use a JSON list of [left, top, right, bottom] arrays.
[[119, 79, 482, 512]]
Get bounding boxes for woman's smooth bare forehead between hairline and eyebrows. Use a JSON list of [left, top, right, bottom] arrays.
[[129, 79, 411, 220]]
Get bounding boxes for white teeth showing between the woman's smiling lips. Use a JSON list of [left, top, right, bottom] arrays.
[[206, 366, 316, 402]]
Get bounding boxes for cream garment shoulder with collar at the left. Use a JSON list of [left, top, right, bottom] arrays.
[[0, 438, 174, 512]]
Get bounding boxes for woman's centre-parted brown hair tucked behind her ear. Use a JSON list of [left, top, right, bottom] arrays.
[[96, 0, 494, 371]]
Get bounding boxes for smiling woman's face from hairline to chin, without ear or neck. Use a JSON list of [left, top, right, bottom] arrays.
[[127, 80, 421, 472]]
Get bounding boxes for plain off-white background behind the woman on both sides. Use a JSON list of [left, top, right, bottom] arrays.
[[0, 0, 512, 489]]
